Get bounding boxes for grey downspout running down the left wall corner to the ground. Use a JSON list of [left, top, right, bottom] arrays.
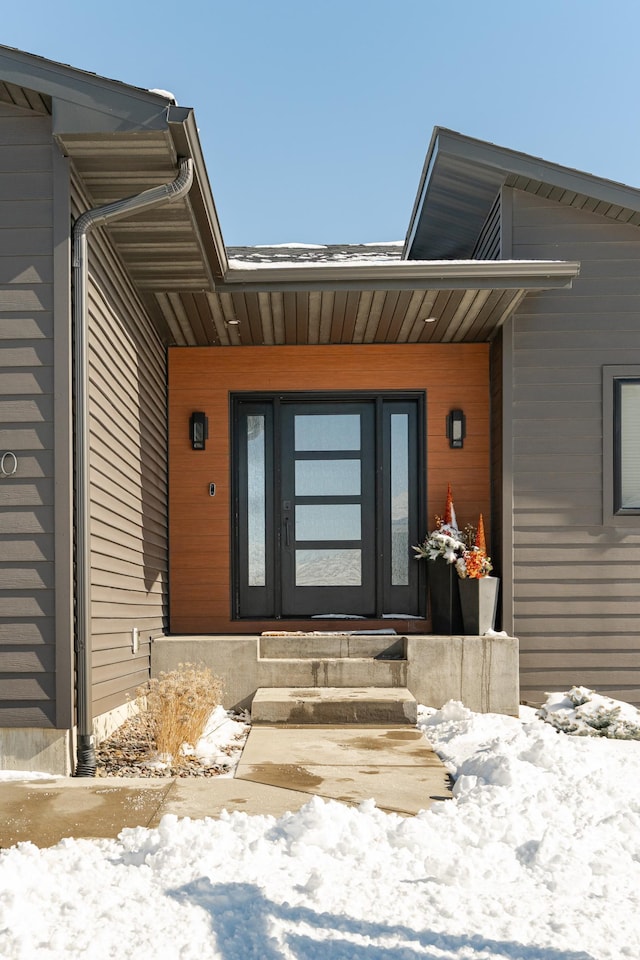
[[73, 159, 193, 777]]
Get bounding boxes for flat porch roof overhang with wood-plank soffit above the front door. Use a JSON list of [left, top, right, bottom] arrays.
[[158, 261, 580, 346]]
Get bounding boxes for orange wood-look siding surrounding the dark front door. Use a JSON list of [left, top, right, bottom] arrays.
[[169, 344, 490, 634]]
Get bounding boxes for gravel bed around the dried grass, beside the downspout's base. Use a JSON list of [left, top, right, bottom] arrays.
[[96, 713, 244, 777]]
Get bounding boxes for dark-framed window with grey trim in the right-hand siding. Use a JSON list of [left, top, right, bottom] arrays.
[[602, 365, 640, 526]]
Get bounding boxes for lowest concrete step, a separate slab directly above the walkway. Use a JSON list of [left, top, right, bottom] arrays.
[[251, 687, 417, 724]]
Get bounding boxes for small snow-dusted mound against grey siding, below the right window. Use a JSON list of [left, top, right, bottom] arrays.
[[538, 687, 640, 740]]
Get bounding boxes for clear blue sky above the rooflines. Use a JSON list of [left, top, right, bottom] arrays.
[[0, 0, 640, 245]]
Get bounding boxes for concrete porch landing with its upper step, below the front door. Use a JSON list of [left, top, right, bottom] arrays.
[[151, 632, 520, 717]]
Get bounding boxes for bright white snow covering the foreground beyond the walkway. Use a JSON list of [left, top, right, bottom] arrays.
[[0, 703, 640, 960]]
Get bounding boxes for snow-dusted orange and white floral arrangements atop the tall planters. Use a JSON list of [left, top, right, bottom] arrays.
[[413, 484, 493, 580]]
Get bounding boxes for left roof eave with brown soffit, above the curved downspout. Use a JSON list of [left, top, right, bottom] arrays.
[[0, 47, 227, 312]]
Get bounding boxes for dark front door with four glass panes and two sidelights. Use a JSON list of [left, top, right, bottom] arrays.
[[233, 394, 425, 619]]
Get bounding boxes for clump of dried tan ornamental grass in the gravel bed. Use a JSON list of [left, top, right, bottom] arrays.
[[137, 663, 222, 761]]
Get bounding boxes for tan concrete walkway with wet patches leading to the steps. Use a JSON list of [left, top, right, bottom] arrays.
[[0, 724, 451, 848]]
